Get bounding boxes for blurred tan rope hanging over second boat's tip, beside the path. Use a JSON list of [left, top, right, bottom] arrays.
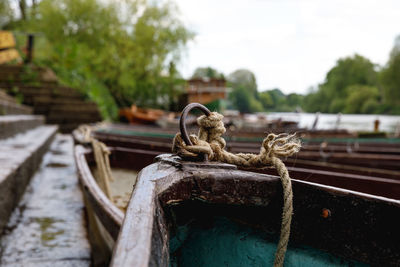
[[78, 125, 114, 201]]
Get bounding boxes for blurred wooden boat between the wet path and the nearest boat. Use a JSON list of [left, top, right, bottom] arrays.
[[74, 145, 158, 266]]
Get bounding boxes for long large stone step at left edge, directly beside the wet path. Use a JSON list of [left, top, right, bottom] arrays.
[[0, 126, 58, 237]]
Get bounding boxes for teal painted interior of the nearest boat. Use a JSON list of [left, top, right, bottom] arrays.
[[170, 217, 368, 267]]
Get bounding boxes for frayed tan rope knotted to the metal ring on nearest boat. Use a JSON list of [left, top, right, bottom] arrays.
[[172, 112, 301, 266]]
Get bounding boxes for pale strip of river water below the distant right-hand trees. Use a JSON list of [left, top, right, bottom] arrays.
[[266, 112, 400, 133]]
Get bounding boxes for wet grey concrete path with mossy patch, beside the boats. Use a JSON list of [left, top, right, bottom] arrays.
[[0, 135, 90, 267]]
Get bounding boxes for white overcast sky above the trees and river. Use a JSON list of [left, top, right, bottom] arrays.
[[175, 0, 400, 93]]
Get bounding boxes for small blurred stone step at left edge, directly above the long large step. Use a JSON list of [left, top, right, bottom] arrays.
[[0, 115, 45, 139]]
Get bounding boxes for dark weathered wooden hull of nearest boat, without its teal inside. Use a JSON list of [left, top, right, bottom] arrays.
[[111, 156, 400, 267]]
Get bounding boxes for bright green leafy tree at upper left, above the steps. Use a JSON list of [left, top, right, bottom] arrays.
[[1, 0, 193, 117]]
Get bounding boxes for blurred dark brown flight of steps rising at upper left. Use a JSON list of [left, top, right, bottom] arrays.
[[0, 66, 102, 133]]
